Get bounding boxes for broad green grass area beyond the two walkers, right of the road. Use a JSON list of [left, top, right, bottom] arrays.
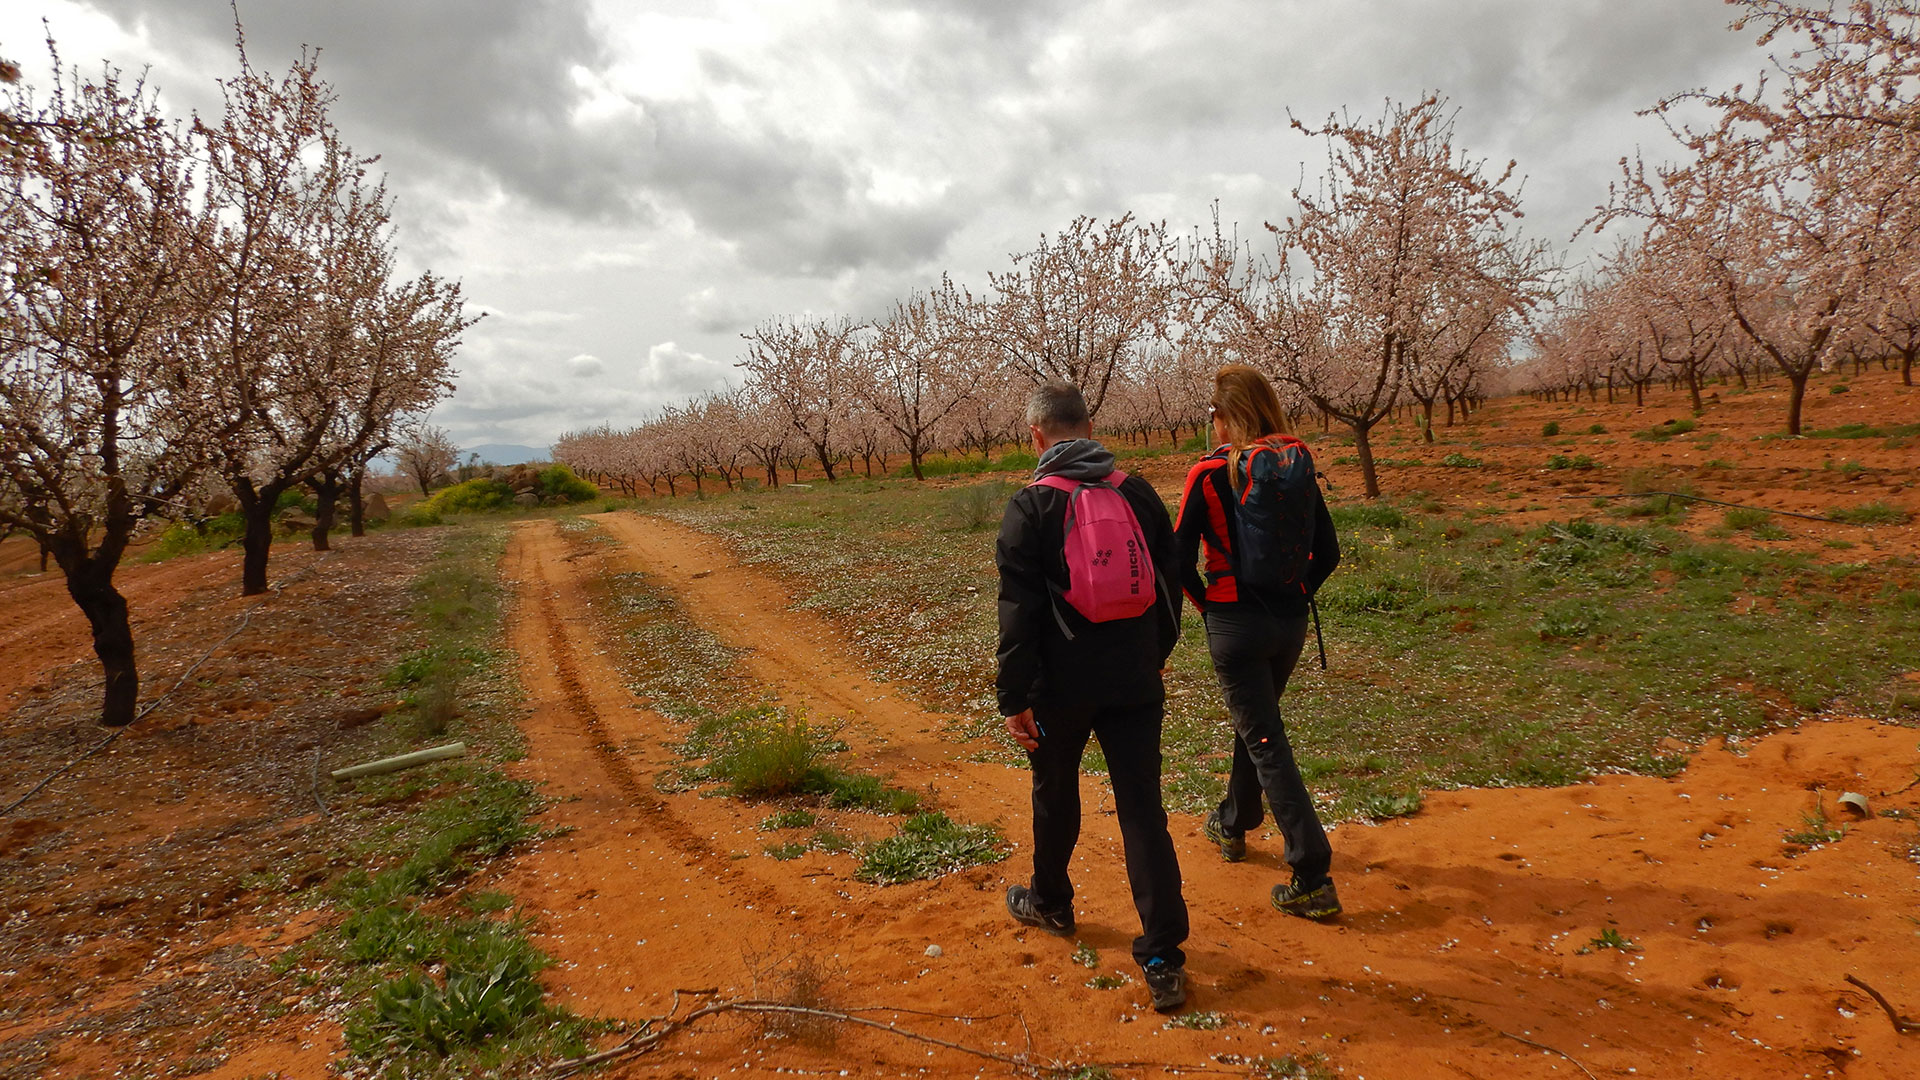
[[659, 467, 1920, 821]]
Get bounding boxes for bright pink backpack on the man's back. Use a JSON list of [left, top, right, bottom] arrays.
[[1035, 469, 1156, 626]]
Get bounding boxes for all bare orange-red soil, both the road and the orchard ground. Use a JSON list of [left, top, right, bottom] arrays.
[[0, 373, 1920, 1078]]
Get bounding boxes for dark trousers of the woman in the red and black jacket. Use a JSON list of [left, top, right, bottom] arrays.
[[1206, 601, 1332, 886]]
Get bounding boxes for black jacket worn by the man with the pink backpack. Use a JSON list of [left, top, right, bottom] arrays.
[[995, 438, 1181, 717]]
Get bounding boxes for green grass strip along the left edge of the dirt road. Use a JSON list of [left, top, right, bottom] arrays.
[[322, 528, 609, 1078]]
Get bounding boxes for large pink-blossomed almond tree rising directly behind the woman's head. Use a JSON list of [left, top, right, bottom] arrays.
[[1190, 96, 1548, 498]]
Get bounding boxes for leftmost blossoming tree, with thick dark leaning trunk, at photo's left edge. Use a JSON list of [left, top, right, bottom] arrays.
[[0, 54, 209, 726]]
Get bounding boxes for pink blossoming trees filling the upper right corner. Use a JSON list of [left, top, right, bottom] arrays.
[[1523, 0, 1920, 434]]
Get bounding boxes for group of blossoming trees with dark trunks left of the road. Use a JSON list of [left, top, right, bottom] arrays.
[[0, 40, 472, 724]]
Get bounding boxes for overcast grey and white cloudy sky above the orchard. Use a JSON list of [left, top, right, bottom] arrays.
[[0, 0, 1763, 446]]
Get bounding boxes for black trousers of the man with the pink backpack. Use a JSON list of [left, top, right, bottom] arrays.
[[1027, 701, 1187, 965]]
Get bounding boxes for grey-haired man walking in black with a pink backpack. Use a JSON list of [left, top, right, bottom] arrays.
[[995, 382, 1187, 1013]]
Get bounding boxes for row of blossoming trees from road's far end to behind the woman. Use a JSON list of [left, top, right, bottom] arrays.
[[555, 96, 1555, 496]]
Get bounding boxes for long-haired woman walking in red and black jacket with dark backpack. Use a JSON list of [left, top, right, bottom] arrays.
[[1175, 365, 1340, 919]]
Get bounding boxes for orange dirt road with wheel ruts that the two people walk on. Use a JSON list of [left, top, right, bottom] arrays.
[[507, 513, 1920, 1076]]
